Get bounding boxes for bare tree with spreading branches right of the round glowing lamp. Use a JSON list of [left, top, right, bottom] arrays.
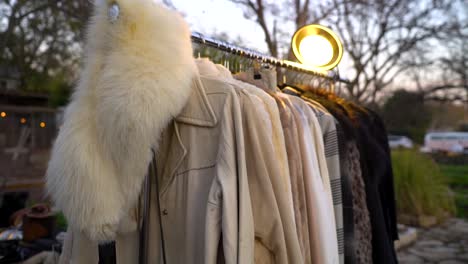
[[333, 0, 464, 102]]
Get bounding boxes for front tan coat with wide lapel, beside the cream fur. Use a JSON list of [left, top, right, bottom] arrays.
[[63, 75, 254, 264]]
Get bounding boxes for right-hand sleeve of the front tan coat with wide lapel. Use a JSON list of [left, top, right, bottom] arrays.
[[205, 91, 254, 264]]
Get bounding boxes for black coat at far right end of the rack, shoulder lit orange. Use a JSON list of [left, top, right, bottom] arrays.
[[296, 88, 398, 263]]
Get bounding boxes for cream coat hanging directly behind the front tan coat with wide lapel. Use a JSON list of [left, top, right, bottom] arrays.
[[197, 59, 303, 263]]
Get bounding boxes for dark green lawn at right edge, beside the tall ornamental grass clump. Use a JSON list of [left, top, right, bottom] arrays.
[[441, 165, 468, 218]]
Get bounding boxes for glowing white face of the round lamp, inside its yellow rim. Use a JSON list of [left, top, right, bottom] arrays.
[[299, 35, 333, 66]]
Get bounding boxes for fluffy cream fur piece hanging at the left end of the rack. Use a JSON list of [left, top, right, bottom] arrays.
[[46, 0, 196, 241]]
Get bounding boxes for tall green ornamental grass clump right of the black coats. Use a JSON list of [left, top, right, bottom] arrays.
[[392, 150, 456, 218]]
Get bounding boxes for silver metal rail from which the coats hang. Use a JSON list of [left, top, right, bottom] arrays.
[[192, 32, 349, 83]]
